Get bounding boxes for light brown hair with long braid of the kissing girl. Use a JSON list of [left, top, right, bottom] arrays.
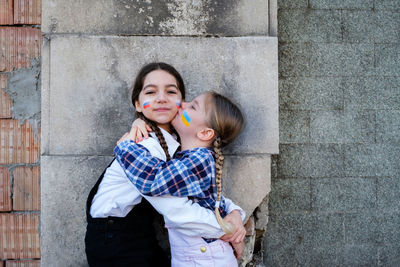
[[207, 92, 245, 234]]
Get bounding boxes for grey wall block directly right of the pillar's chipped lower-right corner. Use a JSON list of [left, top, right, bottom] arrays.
[[269, 179, 311, 212]]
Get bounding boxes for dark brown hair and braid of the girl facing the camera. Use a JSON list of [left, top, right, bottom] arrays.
[[132, 62, 186, 160]]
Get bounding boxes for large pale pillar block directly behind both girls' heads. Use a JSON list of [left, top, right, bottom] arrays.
[[45, 36, 279, 155]]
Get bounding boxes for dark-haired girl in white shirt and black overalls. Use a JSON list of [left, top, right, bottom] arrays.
[[85, 63, 241, 267]]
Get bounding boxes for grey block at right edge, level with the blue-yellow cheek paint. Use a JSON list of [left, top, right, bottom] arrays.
[[376, 110, 400, 144]]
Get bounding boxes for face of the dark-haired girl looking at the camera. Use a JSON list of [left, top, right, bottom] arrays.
[[135, 70, 182, 131]]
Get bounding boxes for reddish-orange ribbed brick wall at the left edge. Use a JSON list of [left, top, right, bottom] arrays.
[[0, 0, 42, 267]]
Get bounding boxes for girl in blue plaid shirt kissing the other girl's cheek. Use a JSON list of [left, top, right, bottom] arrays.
[[114, 92, 244, 267]]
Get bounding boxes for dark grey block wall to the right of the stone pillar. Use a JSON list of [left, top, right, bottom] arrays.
[[264, 0, 400, 266]]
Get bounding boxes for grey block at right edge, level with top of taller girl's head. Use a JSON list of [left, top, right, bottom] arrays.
[[375, 44, 400, 76]]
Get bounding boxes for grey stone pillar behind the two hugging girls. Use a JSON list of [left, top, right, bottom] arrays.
[[41, 0, 279, 266]]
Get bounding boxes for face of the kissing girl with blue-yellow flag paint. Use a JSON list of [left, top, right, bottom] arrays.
[[172, 94, 209, 138]]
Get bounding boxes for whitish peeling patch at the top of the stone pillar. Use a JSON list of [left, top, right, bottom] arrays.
[[159, 0, 212, 35]]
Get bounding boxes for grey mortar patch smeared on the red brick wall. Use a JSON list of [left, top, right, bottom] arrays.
[[4, 60, 41, 125]]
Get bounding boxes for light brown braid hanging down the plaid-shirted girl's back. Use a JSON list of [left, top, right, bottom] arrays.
[[214, 137, 235, 234]]
